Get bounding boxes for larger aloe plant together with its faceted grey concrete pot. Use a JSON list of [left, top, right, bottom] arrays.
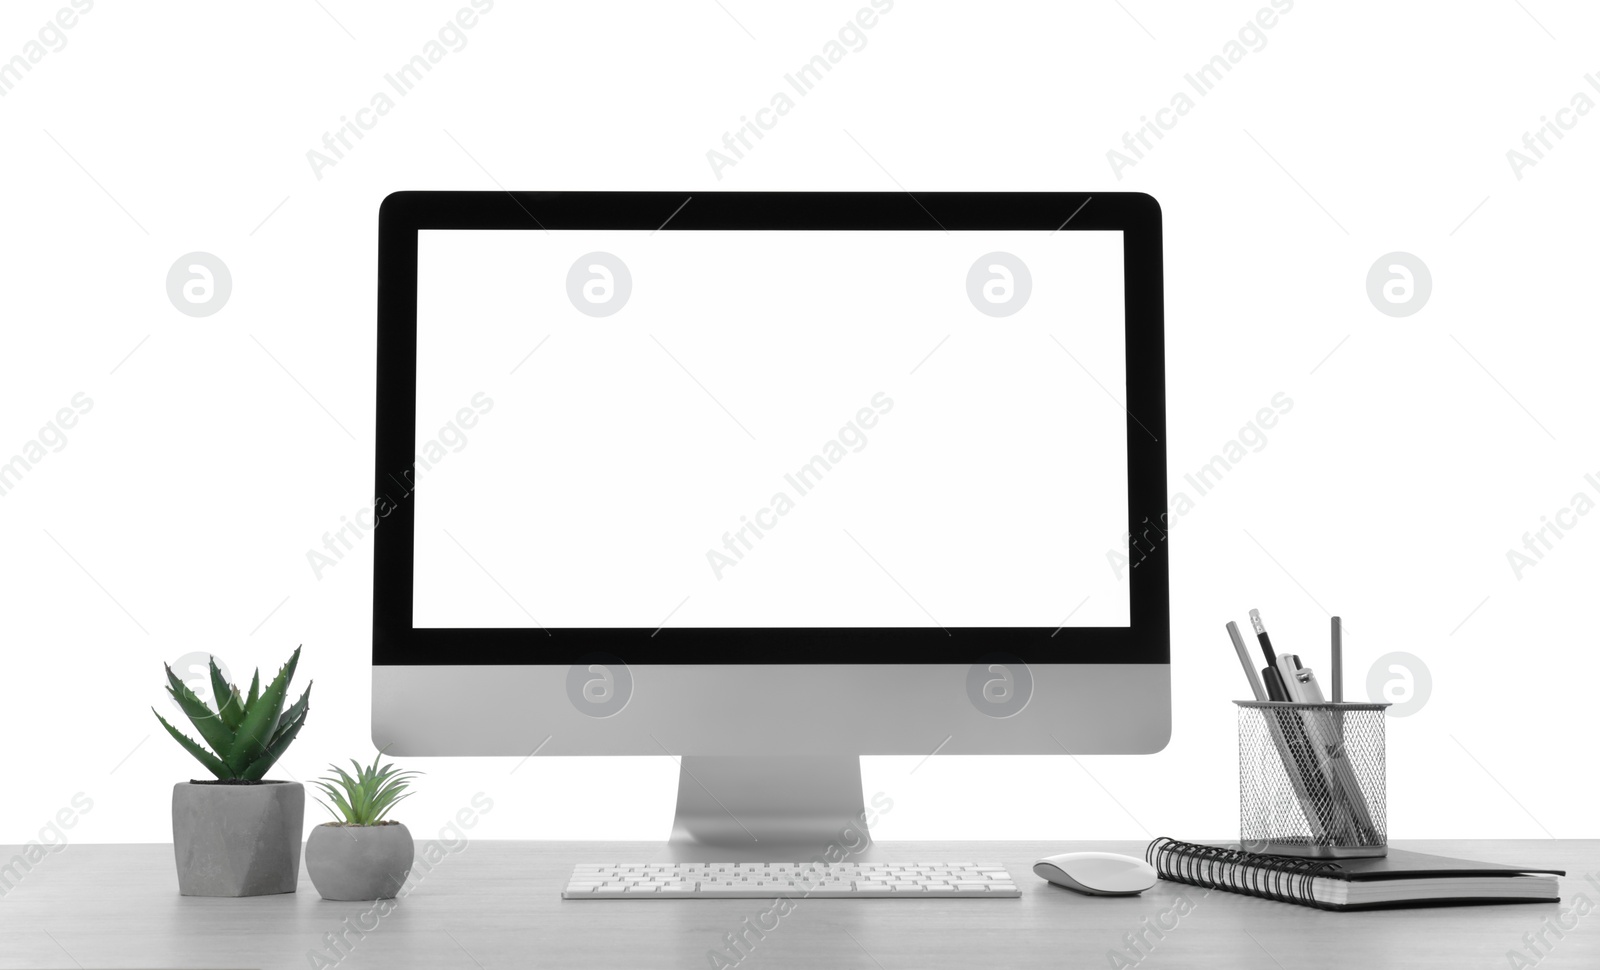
[[152, 647, 310, 896]]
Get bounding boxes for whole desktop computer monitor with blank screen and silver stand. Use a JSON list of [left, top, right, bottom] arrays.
[[373, 192, 1171, 858]]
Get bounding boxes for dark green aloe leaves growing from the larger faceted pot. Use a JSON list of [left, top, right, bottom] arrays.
[[150, 647, 310, 781]]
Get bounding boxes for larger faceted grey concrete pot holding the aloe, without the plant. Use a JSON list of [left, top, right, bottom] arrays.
[[173, 781, 306, 896]]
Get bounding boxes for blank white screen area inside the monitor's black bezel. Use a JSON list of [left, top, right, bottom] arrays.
[[413, 232, 1128, 633]]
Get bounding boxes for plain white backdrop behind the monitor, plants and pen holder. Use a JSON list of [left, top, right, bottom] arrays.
[[0, 0, 1600, 842]]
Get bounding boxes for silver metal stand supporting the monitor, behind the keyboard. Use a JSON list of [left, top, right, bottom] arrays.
[[667, 756, 875, 863]]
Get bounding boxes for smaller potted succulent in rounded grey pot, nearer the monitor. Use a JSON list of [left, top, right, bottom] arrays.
[[306, 752, 419, 900]]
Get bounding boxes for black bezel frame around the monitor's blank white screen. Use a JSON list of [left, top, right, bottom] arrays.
[[373, 192, 1170, 666]]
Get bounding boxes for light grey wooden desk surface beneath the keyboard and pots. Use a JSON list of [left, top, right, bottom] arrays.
[[0, 840, 1600, 970]]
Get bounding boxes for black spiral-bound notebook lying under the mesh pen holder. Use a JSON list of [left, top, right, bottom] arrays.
[[1144, 837, 1566, 911]]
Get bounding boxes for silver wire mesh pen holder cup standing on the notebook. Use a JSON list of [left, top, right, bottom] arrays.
[[1234, 701, 1389, 860]]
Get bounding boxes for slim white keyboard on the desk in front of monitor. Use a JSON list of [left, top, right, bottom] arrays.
[[562, 863, 1022, 900]]
